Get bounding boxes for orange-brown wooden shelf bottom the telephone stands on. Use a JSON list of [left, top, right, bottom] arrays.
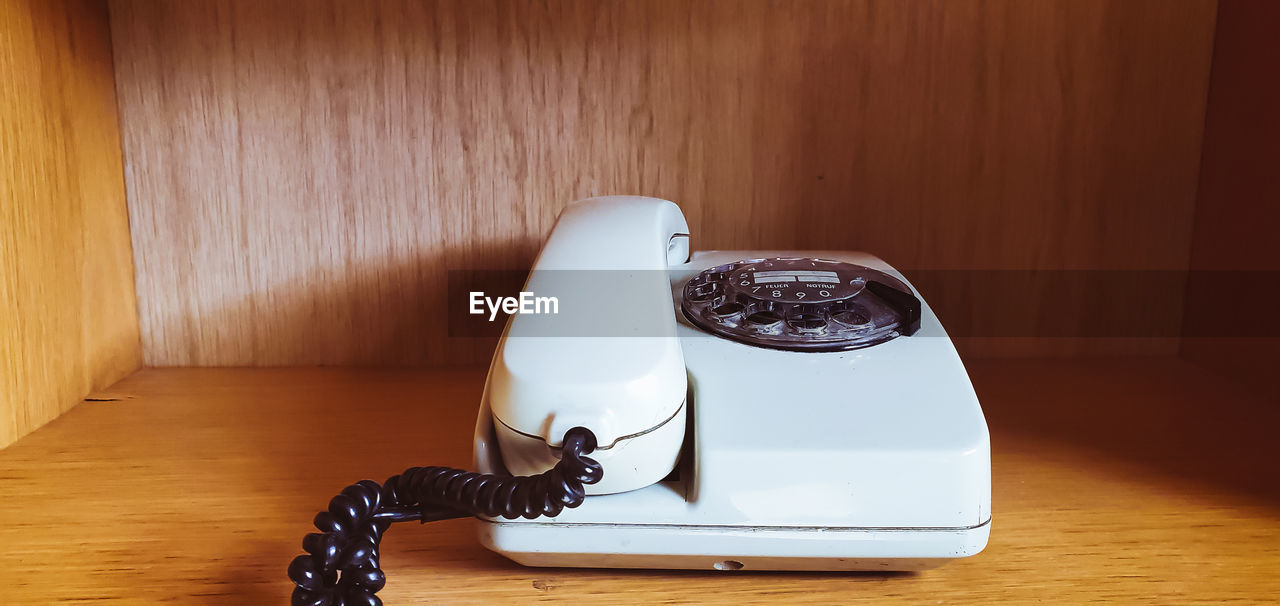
[[0, 359, 1280, 603]]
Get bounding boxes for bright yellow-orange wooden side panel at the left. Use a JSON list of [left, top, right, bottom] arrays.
[[0, 0, 141, 447]]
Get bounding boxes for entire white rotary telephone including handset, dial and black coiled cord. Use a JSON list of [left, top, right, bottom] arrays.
[[289, 196, 991, 605]]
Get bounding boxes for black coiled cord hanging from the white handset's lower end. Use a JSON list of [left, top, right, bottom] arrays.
[[289, 427, 604, 606]]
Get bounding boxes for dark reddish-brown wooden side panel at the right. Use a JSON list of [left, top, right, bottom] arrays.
[[1181, 0, 1280, 398]]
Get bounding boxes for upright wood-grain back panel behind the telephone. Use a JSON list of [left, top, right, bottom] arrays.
[[104, 0, 1216, 365]]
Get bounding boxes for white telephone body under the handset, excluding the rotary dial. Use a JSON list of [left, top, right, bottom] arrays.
[[474, 244, 992, 571]]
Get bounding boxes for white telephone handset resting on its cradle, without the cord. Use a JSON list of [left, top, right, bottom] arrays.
[[488, 196, 689, 495]]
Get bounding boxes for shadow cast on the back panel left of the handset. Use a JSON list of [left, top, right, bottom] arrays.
[[153, 243, 518, 366]]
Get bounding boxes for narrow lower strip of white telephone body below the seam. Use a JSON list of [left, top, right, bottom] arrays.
[[477, 519, 991, 571]]
